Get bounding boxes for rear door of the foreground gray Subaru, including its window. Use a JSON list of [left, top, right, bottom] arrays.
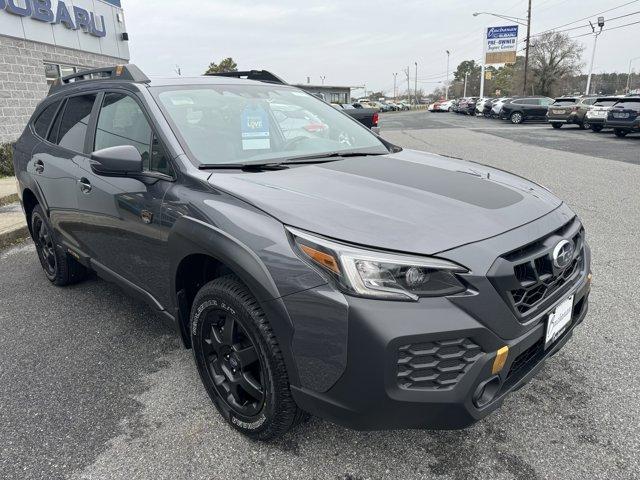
[[27, 93, 97, 245]]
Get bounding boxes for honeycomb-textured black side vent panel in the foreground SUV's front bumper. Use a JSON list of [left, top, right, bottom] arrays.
[[396, 338, 482, 390]]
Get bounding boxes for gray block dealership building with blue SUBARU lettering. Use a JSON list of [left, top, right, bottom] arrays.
[[0, 0, 129, 143]]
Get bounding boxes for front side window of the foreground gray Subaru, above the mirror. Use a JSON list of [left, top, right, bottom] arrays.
[[94, 93, 172, 175]]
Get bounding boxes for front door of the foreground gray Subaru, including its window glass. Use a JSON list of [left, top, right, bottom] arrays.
[[76, 90, 175, 296]]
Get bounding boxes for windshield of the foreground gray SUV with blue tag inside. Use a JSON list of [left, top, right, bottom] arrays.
[[152, 84, 388, 165]]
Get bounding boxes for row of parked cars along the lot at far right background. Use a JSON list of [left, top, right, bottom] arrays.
[[429, 94, 640, 137]]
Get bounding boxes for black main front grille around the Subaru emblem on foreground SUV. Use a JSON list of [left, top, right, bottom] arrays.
[[489, 219, 585, 320]]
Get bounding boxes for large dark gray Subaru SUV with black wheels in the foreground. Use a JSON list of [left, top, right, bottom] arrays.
[[14, 65, 591, 439]]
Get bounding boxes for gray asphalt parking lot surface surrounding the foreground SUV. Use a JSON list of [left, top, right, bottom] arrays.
[[0, 112, 640, 480]]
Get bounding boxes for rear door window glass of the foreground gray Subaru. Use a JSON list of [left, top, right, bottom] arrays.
[[49, 94, 96, 152]]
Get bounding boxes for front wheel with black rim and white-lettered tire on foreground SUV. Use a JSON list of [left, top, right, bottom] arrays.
[[190, 275, 305, 440]]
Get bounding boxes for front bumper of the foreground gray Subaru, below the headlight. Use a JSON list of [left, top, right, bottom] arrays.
[[292, 270, 590, 430]]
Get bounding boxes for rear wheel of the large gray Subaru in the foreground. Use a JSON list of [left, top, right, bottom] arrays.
[[31, 205, 87, 287]]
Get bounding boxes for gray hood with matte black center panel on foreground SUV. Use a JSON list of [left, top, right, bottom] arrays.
[[209, 150, 562, 255]]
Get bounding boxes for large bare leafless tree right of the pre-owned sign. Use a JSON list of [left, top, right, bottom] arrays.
[[530, 32, 584, 96]]
